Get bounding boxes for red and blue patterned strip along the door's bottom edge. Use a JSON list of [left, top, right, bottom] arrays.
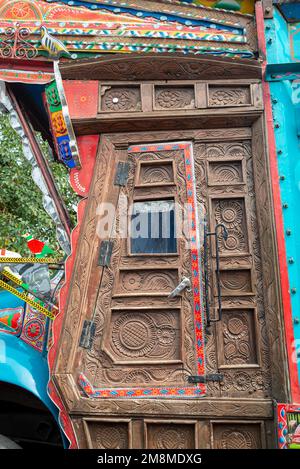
[[78, 373, 205, 399]]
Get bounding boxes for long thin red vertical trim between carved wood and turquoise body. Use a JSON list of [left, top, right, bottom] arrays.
[[255, 2, 300, 402]]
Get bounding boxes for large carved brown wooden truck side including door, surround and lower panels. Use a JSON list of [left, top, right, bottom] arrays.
[[55, 124, 285, 448]]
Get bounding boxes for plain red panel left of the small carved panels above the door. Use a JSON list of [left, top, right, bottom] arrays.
[[63, 80, 99, 119]]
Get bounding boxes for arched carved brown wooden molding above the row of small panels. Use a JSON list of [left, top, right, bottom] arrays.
[[60, 54, 262, 81]]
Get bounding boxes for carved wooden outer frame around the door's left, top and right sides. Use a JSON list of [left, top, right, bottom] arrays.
[[54, 122, 288, 415]]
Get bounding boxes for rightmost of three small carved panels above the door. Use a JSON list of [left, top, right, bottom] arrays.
[[209, 85, 251, 107]]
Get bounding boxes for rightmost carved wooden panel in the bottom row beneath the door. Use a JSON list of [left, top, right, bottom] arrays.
[[213, 423, 261, 449]]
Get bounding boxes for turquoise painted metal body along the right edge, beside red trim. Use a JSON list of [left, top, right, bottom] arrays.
[[265, 8, 300, 381]]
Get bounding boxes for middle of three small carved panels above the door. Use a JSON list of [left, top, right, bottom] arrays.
[[155, 86, 195, 109]]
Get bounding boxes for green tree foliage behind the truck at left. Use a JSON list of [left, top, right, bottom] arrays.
[[0, 115, 78, 256]]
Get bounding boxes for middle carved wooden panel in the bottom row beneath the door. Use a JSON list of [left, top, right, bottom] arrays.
[[147, 424, 195, 450]]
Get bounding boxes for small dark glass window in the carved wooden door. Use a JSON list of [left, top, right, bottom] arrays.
[[131, 200, 177, 254]]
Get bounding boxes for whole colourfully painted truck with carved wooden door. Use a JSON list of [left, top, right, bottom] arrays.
[[0, 0, 299, 449]]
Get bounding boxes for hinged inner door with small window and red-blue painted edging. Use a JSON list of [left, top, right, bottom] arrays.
[[74, 136, 205, 397]]
